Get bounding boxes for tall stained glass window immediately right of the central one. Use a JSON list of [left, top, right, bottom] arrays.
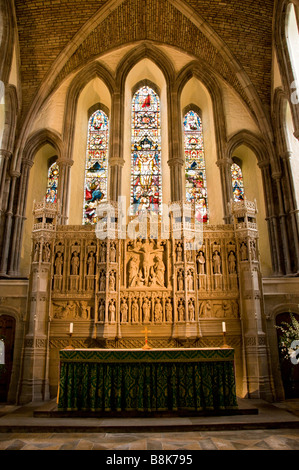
[[184, 110, 209, 223]]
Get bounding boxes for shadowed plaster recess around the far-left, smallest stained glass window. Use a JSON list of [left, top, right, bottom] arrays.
[[20, 143, 59, 276]]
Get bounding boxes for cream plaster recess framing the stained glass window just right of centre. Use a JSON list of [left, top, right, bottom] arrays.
[[180, 77, 223, 225]]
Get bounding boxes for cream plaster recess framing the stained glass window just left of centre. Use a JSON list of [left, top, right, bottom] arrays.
[[66, 77, 111, 225]]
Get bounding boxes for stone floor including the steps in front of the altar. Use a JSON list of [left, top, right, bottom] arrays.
[[0, 400, 299, 451]]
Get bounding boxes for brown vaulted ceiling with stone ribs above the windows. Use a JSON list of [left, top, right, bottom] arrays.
[[15, 0, 274, 123]]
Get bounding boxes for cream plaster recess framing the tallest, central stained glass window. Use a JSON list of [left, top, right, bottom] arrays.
[[122, 58, 171, 218]]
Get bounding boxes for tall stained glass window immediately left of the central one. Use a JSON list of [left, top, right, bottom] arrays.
[[83, 110, 109, 225]]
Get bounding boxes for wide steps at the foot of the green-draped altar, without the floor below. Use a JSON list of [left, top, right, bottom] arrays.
[[0, 399, 299, 433]]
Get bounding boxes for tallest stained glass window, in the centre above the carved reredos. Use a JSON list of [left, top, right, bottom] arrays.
[[131, 86, 162, 214]]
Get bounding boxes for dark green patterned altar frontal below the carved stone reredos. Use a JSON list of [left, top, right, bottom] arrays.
[[58, 348, 238, 412]]
